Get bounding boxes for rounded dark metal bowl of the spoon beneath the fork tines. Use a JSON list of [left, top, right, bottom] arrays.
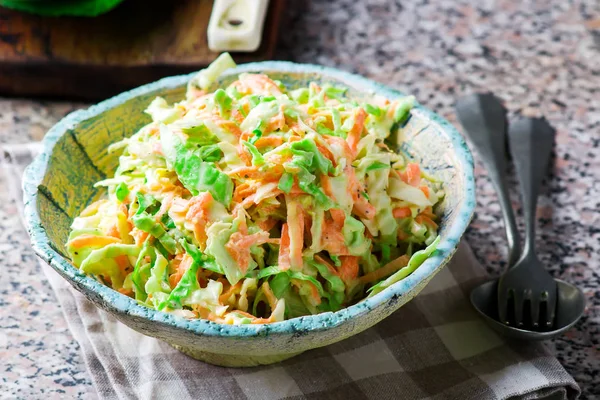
[[471, 279, 585, 340]]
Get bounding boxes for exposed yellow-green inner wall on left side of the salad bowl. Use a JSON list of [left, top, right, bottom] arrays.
[[37, 86, 185, 257]]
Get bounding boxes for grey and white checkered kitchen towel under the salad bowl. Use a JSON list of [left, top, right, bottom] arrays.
[[2, 144, 579, 400]]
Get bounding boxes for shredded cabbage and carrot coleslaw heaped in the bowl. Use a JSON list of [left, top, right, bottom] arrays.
[[67, 54, 443, 324]]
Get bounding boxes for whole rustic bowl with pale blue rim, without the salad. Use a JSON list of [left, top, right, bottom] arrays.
[[23, 62, 475, 366]]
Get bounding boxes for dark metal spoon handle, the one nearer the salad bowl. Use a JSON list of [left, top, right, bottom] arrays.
[[456, 93, 521, 268]]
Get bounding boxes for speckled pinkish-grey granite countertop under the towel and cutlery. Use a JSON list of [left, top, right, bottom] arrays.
[[0, 0, 600, 399]]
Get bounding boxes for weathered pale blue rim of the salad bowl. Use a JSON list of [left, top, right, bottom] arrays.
[[23, 61, 476, 338]]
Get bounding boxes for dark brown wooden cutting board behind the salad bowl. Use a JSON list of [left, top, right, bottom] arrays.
[[0, 0, 284, 100]]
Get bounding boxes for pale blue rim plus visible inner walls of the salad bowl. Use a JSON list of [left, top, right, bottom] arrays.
[[24, 62, 475, 337]]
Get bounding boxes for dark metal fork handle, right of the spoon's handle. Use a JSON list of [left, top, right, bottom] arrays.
[[508, 117, 555, 258]]
